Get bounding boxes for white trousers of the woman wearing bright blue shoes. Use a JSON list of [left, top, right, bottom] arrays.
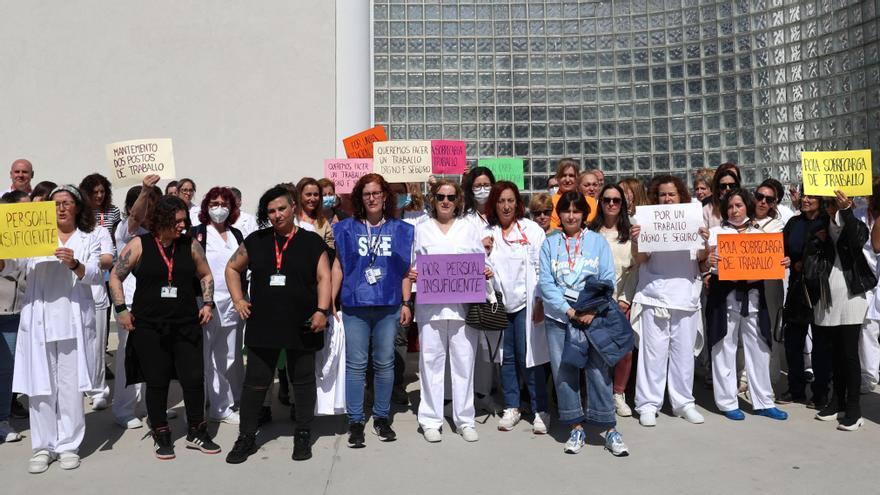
[[712, 308, 775, 412]]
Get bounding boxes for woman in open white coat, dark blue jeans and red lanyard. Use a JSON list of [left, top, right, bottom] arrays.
[[486, 181, 550, 435]]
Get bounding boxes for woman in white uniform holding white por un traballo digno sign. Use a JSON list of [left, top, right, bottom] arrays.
[[631, 175, 706, 427]]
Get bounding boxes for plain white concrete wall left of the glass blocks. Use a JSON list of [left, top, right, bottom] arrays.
[[0, 0, 336, 210]]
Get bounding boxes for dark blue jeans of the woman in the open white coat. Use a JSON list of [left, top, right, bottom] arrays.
[[501, 309, 547, 413]]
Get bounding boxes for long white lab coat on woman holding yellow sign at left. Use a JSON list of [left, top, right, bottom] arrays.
[[0, 229, 104, 397]]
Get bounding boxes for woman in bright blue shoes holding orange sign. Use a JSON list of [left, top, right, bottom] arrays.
[[706, 189, 789, 421]]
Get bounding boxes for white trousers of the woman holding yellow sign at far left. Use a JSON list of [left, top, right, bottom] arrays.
[[28, 339, 86, 454]]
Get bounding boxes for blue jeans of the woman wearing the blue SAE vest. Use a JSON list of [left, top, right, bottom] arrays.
[[342, 306, 400, 424]]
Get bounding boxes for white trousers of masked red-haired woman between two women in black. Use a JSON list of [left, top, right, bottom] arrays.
[[203, 315, 244, 419]]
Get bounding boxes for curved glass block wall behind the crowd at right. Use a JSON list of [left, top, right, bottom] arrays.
[[372, 0, 880, 190]]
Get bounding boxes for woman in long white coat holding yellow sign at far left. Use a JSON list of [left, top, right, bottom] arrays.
[[0, 185, 103, 474]]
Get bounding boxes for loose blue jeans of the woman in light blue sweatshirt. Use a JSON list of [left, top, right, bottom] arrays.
[[544, 318, 617, 428]]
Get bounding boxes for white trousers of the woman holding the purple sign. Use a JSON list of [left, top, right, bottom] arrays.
[[418, 320, 478, 428]]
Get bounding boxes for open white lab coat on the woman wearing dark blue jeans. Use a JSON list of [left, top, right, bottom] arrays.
[[486, 218, 550, 368]]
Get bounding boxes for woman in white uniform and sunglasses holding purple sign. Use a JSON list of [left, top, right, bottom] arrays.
[[410, 180, 491, 442]]
